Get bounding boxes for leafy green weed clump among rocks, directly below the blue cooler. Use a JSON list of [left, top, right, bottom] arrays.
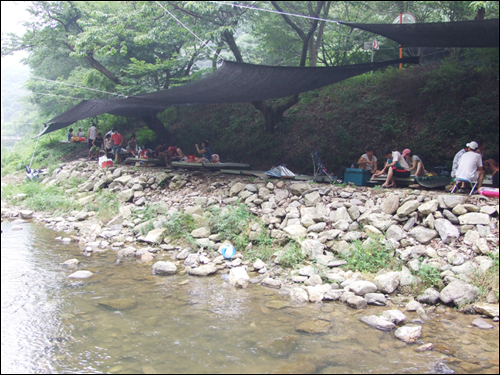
[[345, 238, 391, 273]]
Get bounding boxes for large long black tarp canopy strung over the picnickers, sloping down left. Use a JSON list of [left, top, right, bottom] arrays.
[[39, 57, 418, 136]]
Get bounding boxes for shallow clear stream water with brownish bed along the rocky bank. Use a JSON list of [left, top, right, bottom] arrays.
[[1, 223, 499, 373]]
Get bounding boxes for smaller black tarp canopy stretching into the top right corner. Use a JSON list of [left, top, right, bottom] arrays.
[[339, 18, 499, 48]]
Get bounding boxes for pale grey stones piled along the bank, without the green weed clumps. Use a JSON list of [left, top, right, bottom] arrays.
[[2, 161, 499, 324]]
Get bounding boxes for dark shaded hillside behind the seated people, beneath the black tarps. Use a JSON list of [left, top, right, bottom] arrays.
[[161, 55, 499, 173]]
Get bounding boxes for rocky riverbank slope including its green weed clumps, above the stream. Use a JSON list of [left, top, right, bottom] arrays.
[[2, 160, 499, 350]]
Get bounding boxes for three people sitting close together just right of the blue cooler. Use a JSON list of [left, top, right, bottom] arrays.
[[358, 147, 428, 187]]
